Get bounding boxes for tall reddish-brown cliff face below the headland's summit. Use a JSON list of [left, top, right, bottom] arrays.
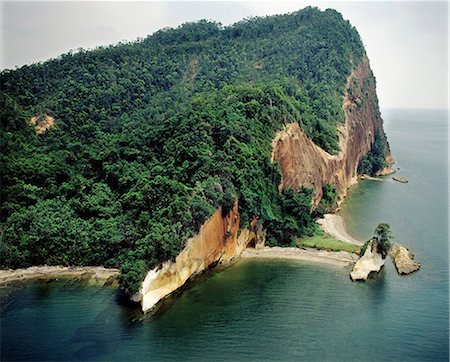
[[272, 57, 393, 203]]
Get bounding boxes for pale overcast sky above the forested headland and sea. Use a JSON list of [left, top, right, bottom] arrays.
[[0, 0, 449, 108]]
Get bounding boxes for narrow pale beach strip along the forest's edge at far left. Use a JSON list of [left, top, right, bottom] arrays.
[[0, 265, 119, 286]]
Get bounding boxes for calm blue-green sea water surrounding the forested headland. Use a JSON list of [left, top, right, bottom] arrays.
[[1, 111, 449, 361]]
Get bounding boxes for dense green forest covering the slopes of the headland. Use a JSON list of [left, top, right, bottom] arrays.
[[0, 8, 370, 291]]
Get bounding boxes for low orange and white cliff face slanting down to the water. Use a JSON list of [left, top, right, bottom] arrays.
[[140, 203, 263, 311]]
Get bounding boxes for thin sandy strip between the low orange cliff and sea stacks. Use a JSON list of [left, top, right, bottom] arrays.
[[240, 246, 359, 266]]
